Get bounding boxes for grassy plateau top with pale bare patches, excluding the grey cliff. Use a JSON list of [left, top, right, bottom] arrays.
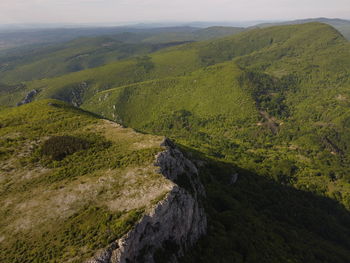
[[0, 100, 171, 263]]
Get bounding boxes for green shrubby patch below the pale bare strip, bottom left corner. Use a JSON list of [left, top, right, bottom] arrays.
[[0, 205, 143, 263]]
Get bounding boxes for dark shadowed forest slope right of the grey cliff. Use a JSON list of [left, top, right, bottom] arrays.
[[181, 157, 350, 263]]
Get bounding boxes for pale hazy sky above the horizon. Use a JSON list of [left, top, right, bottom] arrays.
[[0, 0, 350, 24]]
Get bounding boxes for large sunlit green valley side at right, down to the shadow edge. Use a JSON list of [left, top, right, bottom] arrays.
[[82, 23, 350, 208]]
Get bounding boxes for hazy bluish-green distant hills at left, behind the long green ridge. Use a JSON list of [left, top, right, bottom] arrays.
[[0, 27, 244, 84]]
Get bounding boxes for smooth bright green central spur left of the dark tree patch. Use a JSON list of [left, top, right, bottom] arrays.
[[83, 62, 258, 128]]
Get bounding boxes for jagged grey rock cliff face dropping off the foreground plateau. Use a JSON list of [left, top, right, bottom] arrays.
[[86, 139, 207, 263]]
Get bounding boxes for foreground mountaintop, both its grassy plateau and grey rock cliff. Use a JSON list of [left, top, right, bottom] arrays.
[[0, 100, 206, 263]]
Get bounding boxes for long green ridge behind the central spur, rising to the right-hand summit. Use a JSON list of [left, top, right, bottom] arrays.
[[0, 24, 334, 105]]
